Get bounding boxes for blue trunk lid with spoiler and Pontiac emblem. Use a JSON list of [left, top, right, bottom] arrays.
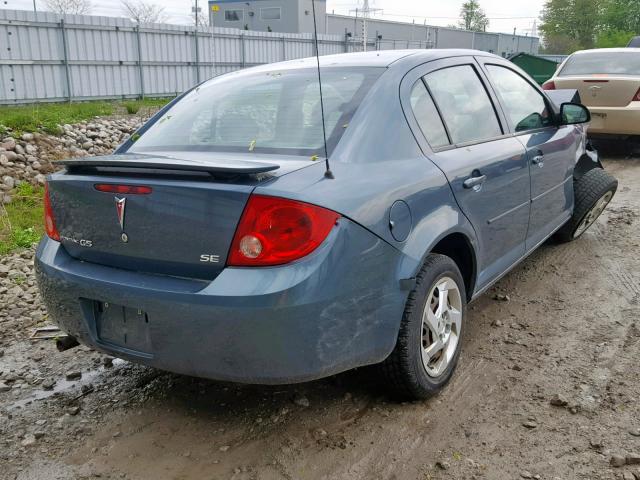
[[48, 152, 313, 279]]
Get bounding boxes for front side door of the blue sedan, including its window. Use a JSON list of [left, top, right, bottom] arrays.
[[480, 58, 584, 250]]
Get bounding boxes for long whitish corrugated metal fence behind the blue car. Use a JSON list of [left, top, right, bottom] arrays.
[[0, 9, 536, 104]]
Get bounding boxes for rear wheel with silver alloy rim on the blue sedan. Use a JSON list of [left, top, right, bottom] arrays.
[[381, 254, 466, 400]]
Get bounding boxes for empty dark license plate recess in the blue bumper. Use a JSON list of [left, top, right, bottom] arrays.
[[94, 301, 152, 353]]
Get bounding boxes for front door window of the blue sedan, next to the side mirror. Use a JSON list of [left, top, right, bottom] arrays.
[[487, 65, 552, 132]]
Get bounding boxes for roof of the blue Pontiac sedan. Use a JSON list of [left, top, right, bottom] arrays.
[[242, 48, 501, 71]]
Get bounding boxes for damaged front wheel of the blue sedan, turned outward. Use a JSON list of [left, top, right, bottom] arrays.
[[555, 168, 618, 242]]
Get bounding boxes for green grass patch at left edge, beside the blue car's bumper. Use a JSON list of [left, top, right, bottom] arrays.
[[0, 183, 44, 255]]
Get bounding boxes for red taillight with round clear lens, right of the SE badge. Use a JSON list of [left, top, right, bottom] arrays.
[[227, 195, 340, 267]]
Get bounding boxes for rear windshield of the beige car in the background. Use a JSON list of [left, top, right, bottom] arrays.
[[559, 52, 640, 77]]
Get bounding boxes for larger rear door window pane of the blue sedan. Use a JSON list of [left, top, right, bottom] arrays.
[[424, 65, 502, 143]]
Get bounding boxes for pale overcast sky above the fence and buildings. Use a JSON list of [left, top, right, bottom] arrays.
[[0, 0, 544, 35]]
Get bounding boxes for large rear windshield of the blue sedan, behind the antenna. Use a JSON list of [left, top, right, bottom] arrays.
[[129, 67, 384, 156]]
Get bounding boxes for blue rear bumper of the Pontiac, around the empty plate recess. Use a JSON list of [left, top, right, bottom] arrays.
[[35, 218, 407, 384]]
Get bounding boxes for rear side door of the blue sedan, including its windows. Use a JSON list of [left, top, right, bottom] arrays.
[[402, 57, 530, 288]]
